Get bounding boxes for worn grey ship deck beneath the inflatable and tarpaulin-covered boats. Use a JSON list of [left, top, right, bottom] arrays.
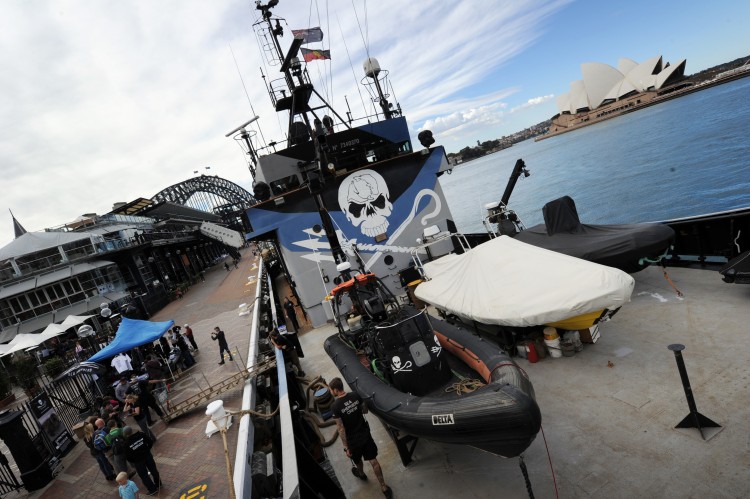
[[301, 267, 750, 498]]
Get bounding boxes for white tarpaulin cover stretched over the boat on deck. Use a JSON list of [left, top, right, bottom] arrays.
[[414, 236, 635, 326]]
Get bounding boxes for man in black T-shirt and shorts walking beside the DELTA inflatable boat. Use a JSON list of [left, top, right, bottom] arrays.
[[328, 378, 393, 499]]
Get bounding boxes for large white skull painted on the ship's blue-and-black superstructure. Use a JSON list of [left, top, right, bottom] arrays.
[[339, 169, 393, 237]]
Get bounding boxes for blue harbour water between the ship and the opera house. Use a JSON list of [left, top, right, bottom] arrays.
[[438, 78, 750, 233]]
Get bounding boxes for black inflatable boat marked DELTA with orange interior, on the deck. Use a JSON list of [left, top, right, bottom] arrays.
[[325, 274, 541, 457]]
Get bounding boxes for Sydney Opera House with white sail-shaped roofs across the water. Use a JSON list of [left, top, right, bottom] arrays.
[[549, 56, 686, 134]]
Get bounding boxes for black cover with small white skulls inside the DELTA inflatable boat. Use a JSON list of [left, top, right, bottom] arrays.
[[372, 312, 452, 396]]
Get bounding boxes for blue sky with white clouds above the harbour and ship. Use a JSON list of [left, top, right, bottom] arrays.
[[0, 0, 750, 245]]
